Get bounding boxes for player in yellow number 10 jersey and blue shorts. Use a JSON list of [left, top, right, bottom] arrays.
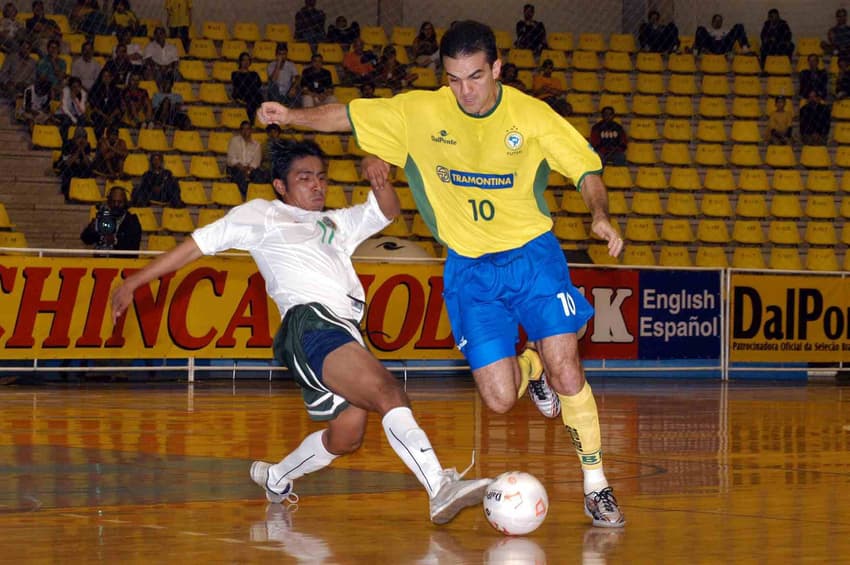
[[260, 21, 625, 528]]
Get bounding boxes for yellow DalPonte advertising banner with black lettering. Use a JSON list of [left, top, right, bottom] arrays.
[[729, 273, 850, 363]]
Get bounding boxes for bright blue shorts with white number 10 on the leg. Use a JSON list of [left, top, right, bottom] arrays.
[[443, 232, 593, 370]]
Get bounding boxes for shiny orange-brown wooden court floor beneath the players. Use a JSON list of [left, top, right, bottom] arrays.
[[0, 379, 850, 565]]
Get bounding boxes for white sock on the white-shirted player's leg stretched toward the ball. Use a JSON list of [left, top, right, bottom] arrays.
[[382, 406, 443, 498]]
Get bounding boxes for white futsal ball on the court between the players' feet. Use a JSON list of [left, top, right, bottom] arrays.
[[484, 471, 549, 536]]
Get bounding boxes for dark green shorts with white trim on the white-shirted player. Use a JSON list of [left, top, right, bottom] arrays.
[[272, 302, 363, 421]]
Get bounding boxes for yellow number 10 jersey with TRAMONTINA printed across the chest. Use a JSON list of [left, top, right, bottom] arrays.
[[348, 85, 602, 257]]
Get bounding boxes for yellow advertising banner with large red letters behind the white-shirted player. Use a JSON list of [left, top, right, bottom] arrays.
[[0, 257, 461, 360]]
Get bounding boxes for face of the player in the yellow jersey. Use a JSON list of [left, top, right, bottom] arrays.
[[443, 51, 502, 115]]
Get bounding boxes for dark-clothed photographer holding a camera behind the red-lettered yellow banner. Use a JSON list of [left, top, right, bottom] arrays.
[[80, 186, 142, 251]]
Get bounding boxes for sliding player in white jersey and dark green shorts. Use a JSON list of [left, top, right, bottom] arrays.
[[112, 141, 491, 524]]
